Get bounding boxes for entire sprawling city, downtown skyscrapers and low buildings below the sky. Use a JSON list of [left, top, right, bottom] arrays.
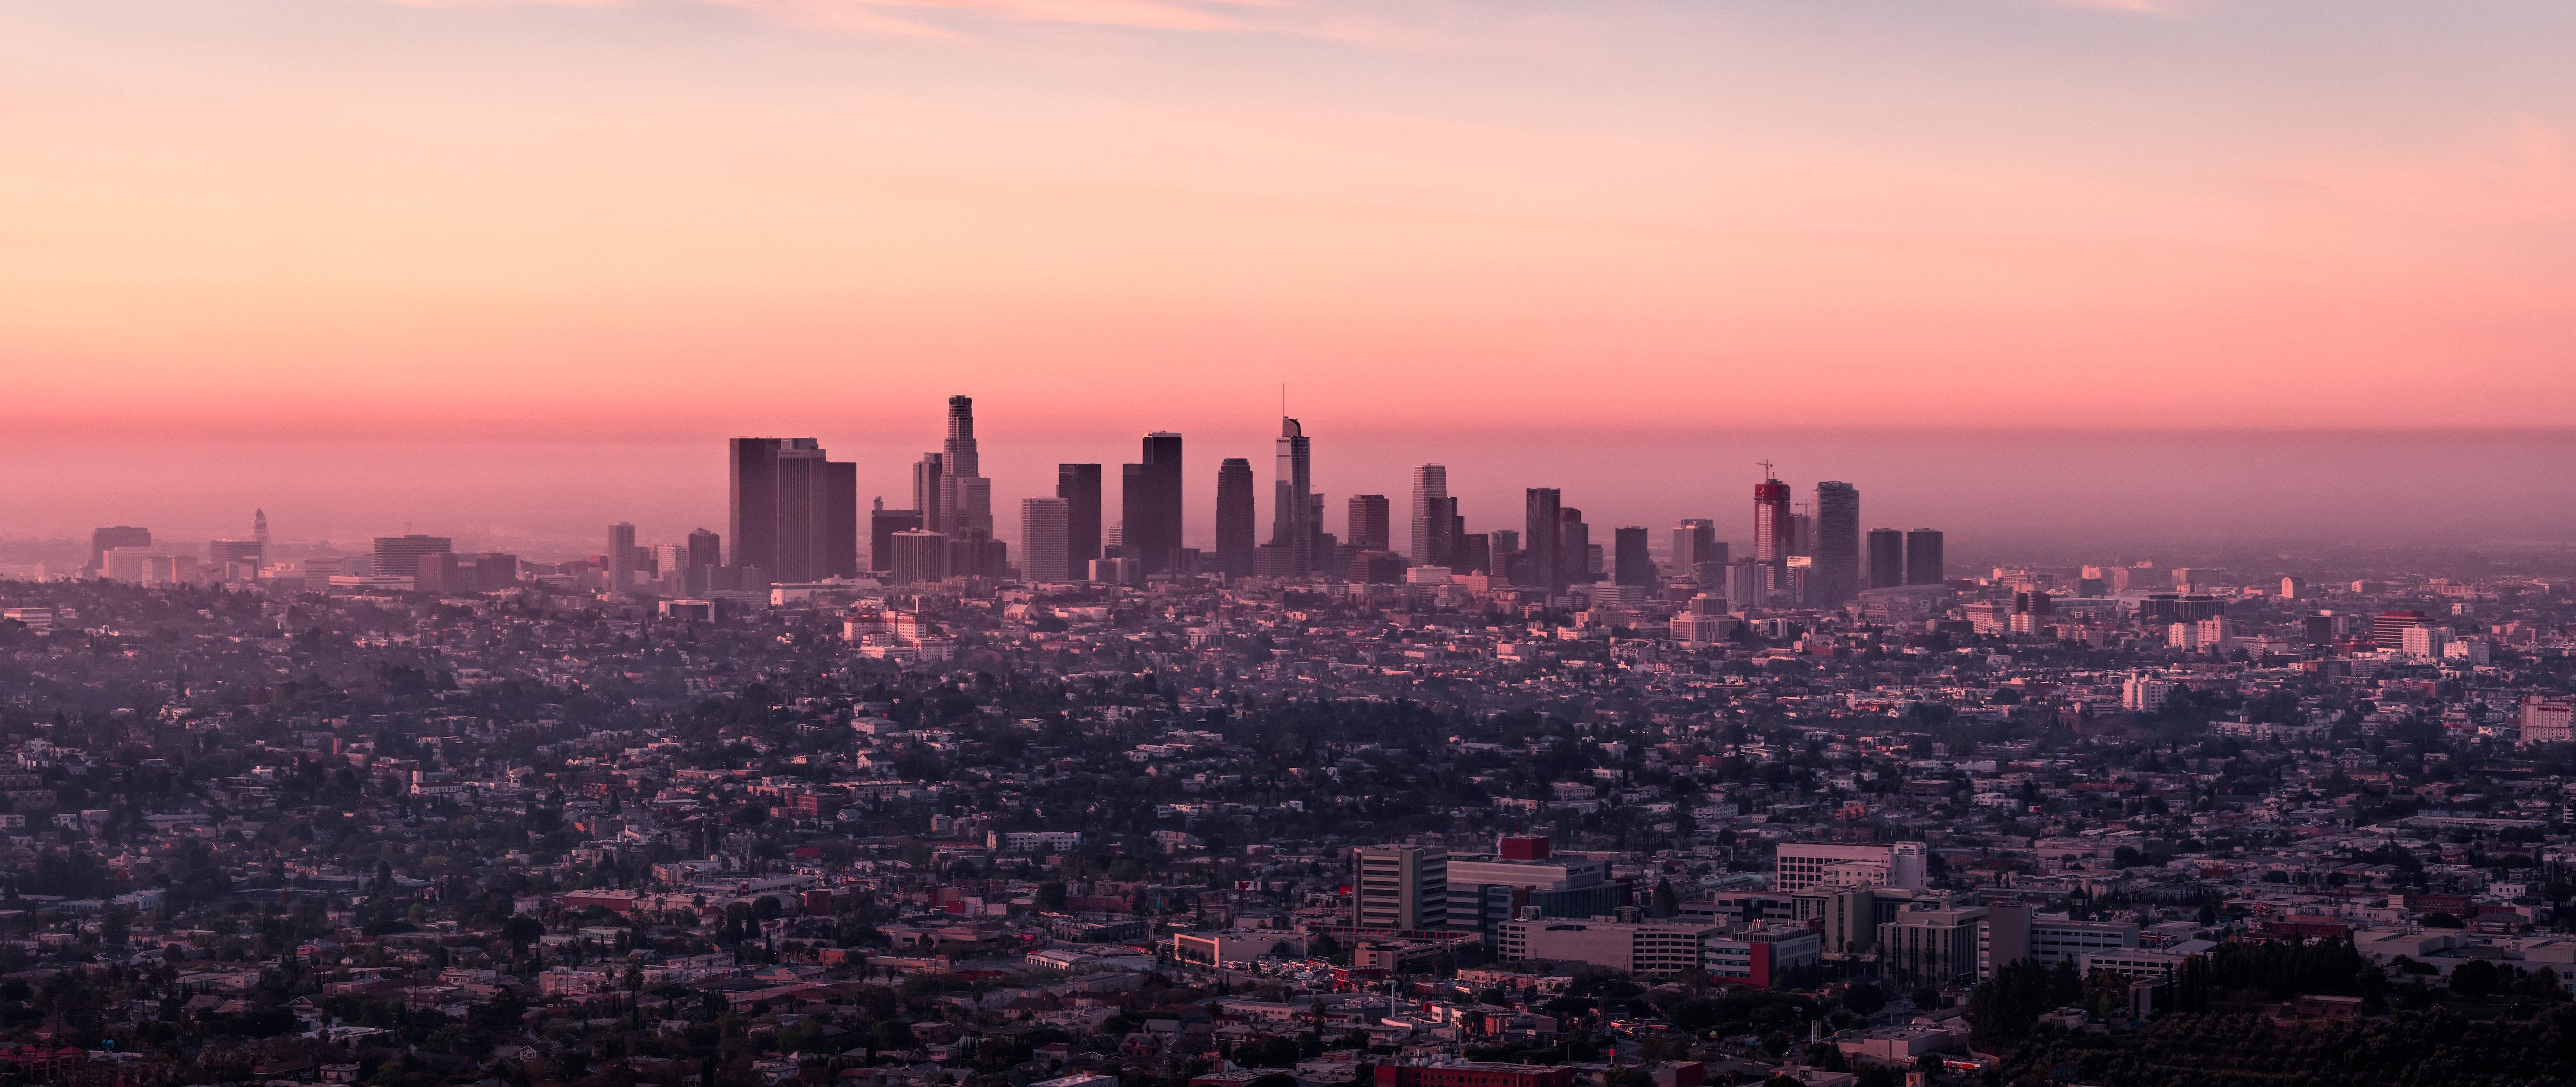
[[0, 397, 2576, 1087]]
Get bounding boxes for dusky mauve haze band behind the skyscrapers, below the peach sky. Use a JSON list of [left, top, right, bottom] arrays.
[[0, 420, 2576, 562]]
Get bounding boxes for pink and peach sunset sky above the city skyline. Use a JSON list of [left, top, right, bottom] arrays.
[[0, 0, 2576, 551]]
